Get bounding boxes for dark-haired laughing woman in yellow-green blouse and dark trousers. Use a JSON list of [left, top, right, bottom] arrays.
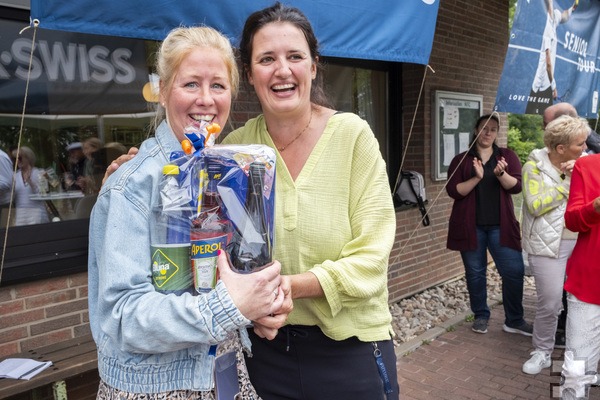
[[219, 3, 399, 400]]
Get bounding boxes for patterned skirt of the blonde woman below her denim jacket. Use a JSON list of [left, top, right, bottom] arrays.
[[96, 332, 261, 400]]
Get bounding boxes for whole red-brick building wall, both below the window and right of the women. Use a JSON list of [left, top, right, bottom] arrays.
[[0, 0, 508, 357]]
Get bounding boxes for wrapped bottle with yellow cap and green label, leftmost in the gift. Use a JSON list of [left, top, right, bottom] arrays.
[[151, 164, 192, 295]]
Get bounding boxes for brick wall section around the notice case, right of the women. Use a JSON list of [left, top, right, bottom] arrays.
[[389, 0, 508, 301]]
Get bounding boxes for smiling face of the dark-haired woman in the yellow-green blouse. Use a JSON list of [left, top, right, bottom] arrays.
[[248, 22, 317, 114]]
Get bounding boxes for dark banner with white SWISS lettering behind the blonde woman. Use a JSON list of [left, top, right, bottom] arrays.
[[0, 20, 148, 114]]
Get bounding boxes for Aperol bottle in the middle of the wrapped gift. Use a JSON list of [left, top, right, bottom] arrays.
[[191, 158, 233, 293]]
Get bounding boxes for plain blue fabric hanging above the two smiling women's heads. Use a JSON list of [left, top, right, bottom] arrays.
[[31, 0, 440, 64]]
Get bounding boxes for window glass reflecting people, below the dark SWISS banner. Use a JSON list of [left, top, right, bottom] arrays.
[[0, 113, 154, 227]]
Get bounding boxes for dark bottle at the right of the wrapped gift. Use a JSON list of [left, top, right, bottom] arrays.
[[229, 162, 272, 273]]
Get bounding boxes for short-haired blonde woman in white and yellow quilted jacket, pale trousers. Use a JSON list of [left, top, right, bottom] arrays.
[[522, 115, 590, 375]]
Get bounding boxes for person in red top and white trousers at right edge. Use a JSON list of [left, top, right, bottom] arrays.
[[562, 154, 600, 400]]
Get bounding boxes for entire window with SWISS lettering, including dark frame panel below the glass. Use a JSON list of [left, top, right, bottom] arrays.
[[0, 6, 154, 285]]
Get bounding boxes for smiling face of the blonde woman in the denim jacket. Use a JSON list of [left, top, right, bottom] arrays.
[[160, 47, 232, 141]]
